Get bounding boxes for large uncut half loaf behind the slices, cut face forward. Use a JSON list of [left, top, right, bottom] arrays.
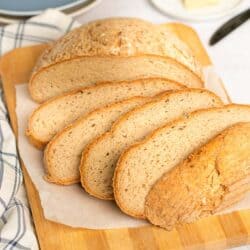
[[29, 18, 203, 102]]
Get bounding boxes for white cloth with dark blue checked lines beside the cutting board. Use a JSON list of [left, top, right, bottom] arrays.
[[0, 9, 79, 249]]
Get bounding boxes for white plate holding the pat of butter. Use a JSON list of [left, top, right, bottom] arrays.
[[150, 0, 242, 21]]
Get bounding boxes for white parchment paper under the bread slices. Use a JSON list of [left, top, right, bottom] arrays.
[[16, 67, 250, 229]]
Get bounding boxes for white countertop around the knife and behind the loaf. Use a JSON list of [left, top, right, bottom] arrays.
[[77, 0, 250, 104]]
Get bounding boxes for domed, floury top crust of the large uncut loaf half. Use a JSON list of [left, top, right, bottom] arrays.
[[30, 18, 202, 78]]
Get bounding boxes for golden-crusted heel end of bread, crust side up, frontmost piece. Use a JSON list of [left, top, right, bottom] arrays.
[[145, 123, 250, 230]]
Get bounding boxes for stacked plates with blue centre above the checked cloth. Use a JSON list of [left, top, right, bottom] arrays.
[[0, 0, 101, 23]]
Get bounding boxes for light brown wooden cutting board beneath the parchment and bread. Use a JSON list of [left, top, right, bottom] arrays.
[[0, 24, 250, 250]]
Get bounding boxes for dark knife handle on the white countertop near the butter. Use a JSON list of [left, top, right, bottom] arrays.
[[209, 9, 250, 45]]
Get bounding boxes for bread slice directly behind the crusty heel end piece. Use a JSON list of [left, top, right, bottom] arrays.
[[113, 105, 250, 218]]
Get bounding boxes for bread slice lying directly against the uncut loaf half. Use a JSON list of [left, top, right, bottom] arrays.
[[27, 79, 183, 148]]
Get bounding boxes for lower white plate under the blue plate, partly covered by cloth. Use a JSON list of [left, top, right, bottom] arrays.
[[0, 0, 102, 24]]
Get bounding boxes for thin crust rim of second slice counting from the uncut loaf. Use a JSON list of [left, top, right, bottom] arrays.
[[43, 96, 153, 187]]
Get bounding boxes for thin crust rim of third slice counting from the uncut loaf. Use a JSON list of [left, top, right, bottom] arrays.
[[80, 88, 223, 202]]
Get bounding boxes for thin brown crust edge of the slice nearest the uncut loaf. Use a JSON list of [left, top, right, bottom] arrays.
[[26, 78, 185, 149]]
